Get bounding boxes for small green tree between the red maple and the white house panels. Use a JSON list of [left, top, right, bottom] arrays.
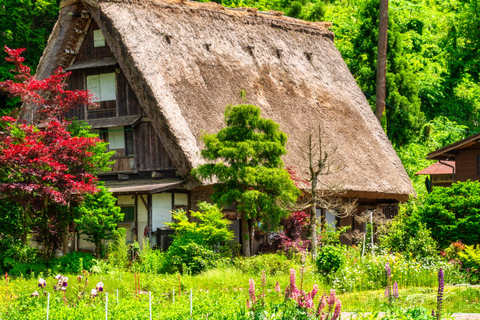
[[74, 186, 123, 258]]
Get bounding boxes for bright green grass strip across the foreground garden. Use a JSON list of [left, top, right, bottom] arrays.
[[0, 267, 480, 319]]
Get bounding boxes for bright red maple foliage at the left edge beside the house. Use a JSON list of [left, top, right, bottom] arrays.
[[0, 47, 100, 208]]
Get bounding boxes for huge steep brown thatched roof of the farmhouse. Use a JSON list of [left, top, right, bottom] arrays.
[[37, 0, 414, 200]]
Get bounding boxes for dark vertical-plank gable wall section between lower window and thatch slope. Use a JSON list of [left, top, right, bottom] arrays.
[[135, 122, 175, 171]]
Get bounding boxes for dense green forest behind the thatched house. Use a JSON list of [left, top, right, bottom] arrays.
[[0, 0, 480, 194]]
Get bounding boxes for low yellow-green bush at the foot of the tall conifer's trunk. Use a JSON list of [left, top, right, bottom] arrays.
[[234, 253, 296, 275]]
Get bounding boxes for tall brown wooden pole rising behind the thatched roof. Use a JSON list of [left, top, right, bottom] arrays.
[[375, 0, 388, 121]]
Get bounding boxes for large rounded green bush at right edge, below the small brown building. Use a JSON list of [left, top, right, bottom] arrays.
[[416, 181, 480, 248]]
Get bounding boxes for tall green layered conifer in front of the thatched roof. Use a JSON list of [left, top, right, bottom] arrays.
[[192, 105, 300, 256]]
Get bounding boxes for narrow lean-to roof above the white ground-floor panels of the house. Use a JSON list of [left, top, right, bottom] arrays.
[[105, 179, 185, 194]]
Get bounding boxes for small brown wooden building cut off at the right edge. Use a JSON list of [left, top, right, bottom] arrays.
[[416, 133, 480, 187]]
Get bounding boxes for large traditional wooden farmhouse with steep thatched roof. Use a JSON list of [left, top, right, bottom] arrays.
[[33, 0, 414, 249]]
